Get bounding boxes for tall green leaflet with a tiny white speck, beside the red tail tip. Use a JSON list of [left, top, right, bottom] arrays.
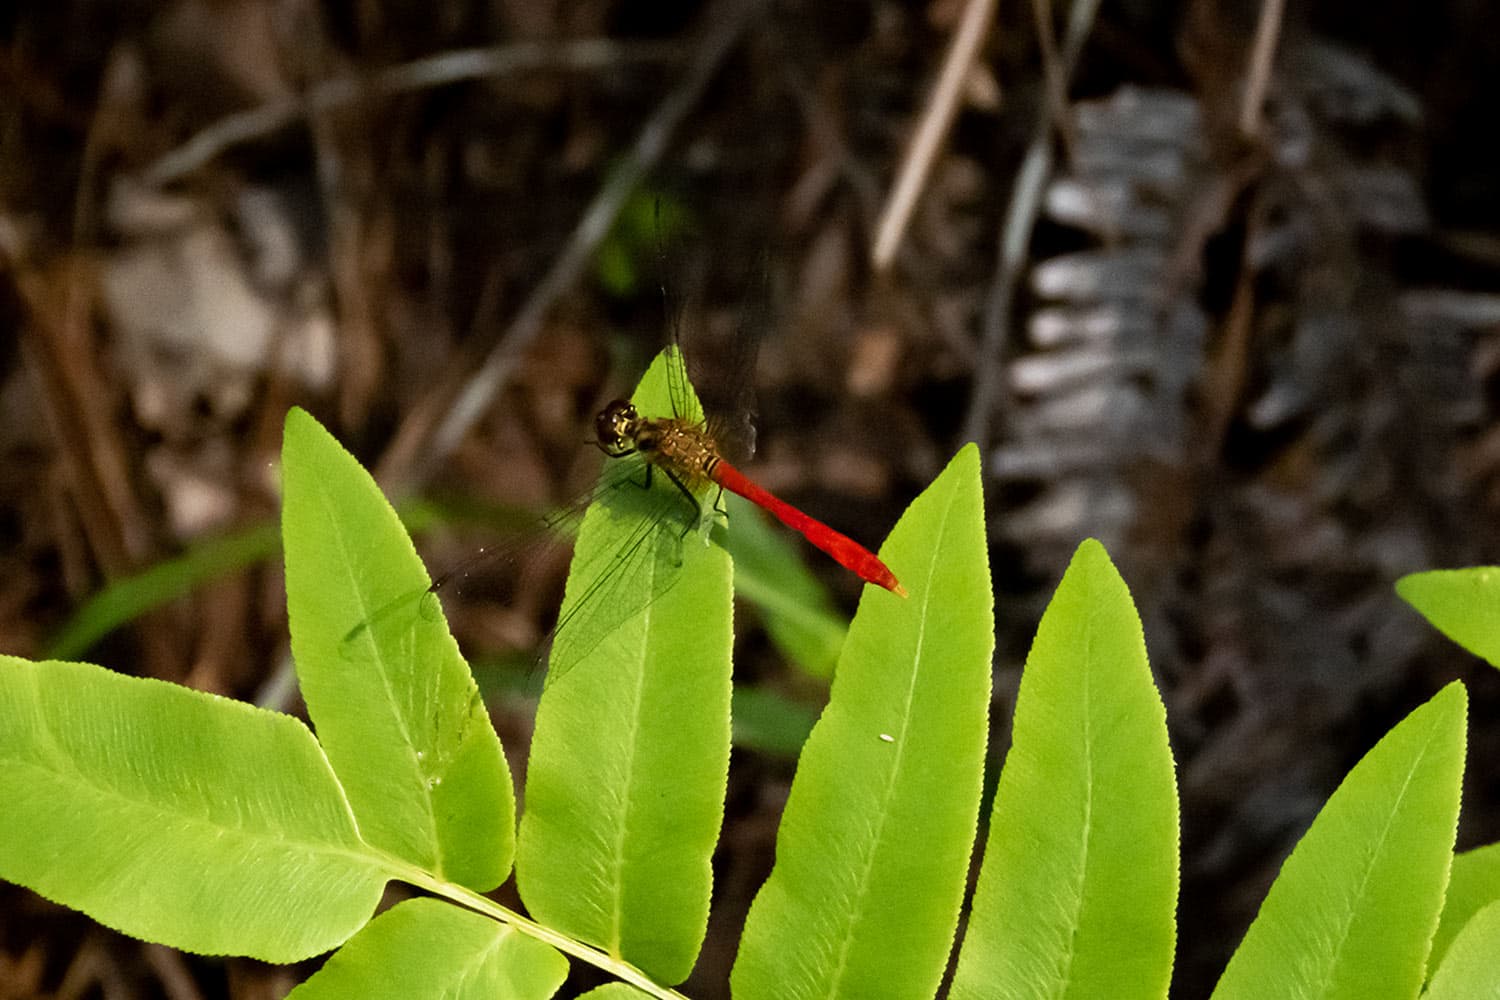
[[731, 445, 995, 1000]]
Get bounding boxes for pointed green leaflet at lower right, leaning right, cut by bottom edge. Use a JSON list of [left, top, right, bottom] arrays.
[[1214, 681, 1467, 1000]]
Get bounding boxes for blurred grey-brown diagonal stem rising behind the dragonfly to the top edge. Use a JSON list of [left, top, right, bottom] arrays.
[[377, 0, 765, 496]]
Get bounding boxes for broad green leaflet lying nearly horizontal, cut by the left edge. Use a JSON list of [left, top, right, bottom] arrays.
[[0, 657, 387, 963]]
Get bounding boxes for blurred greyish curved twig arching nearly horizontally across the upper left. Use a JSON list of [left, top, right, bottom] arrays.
[[141, 39, 681, 187]]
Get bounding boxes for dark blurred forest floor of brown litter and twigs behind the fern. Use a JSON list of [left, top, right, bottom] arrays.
[[0, 0, 1500, 999]]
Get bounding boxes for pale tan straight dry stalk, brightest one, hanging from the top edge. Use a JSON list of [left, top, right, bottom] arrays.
[[870, 0, 996, 271]]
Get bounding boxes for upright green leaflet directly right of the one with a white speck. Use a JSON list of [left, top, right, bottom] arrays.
[[951, 540, 1178, 1000]]
